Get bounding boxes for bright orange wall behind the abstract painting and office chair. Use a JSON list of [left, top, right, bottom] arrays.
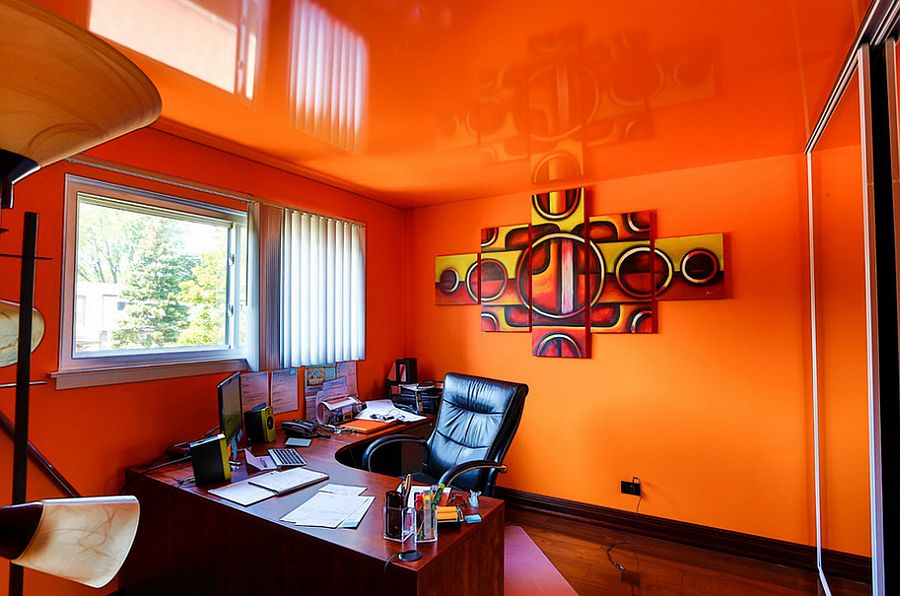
[[407, 156, 815, 544]]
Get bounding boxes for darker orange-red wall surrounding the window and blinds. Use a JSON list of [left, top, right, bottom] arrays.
[[0, 130, 404, 594]]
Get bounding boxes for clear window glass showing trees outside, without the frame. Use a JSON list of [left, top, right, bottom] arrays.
[[74, 194, 232, 356]]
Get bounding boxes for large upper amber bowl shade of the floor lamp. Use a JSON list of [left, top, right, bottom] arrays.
[[0, 0, 162, 207]]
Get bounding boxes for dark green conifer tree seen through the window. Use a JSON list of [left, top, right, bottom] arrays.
[[112, 218, 197, 349]]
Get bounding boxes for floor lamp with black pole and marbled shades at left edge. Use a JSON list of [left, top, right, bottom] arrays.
[[0, 0, 161, 596]]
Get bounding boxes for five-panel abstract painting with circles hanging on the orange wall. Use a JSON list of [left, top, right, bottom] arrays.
[[434, 188, 725, 358]]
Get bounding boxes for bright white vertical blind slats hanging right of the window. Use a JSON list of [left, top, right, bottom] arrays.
[[281, 211, 366, 366]]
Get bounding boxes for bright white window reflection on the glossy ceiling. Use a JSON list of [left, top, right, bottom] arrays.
[[89, 0, 268, 99]]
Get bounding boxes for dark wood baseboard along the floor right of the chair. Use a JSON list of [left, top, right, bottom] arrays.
[[495, 486, 872, 584]]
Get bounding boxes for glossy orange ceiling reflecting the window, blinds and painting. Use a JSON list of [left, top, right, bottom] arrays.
[[41, 0, 868, 206]]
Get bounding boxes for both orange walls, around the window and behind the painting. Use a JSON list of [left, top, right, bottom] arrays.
[[0, 114, 872, 593]]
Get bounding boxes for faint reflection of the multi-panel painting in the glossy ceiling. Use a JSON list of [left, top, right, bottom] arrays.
[[438, 26, 716, 185]]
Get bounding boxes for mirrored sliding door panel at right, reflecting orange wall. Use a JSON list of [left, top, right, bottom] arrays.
[[809, 60, 871, 595]]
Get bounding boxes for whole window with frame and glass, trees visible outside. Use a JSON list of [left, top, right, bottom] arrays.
[[58, 176, 246, 388]]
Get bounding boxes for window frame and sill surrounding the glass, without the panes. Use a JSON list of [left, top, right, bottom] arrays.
[[50, 174, 248, 389]]
